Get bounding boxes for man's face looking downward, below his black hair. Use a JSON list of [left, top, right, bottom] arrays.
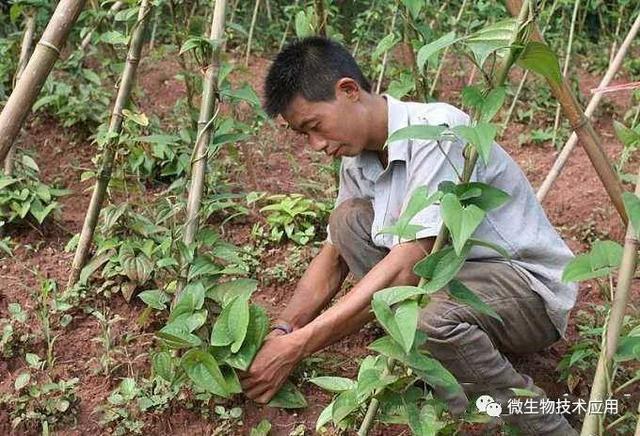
[[282, 81, 368, 157]]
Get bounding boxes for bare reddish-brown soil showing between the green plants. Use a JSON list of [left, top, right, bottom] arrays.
[[0, 46, 639, 435]]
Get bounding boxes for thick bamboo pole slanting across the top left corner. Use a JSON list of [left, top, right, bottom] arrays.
[[0, 0, 86, 161]]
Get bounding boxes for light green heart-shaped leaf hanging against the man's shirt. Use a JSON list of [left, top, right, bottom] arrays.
[[440, 194, 485, 255]]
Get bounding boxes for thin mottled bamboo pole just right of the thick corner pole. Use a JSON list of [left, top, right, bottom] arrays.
[[67, 0, 151, 287]]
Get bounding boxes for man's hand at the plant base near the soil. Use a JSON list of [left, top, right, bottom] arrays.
[[240, 330, 304, 403]]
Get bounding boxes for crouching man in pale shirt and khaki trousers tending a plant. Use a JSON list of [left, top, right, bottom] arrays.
[[242, 37, 577, 436]]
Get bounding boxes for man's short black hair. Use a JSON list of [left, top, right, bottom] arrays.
[[264, 36, 371, 117]]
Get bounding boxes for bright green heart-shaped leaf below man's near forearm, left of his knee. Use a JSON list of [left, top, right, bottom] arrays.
[[372, 299, 418, 352]]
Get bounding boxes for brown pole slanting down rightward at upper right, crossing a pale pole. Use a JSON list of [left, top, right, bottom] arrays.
[[507, 0, 627, 224]]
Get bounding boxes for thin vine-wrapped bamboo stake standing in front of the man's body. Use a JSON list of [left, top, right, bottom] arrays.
[[358, 0, 531, 436]]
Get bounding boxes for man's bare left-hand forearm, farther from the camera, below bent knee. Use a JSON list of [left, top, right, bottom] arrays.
[[278, 244, 349, 329]]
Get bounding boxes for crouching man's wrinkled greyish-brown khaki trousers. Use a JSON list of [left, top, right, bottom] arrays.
[[329, 198, 578, 436]]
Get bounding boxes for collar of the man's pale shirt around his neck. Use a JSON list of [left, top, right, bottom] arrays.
[[355, 94, 409, 180]]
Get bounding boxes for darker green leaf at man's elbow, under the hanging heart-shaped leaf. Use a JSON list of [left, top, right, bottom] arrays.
[[413, 244, 470, 294]]
